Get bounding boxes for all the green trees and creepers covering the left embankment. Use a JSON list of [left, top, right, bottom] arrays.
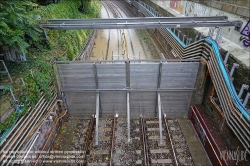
[[0, 0, 101, 131]]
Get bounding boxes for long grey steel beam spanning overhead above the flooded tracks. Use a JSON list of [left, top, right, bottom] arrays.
[[41, 16, 242, 30]]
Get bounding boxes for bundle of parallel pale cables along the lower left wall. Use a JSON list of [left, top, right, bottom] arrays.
[[0, 94, 57, 165]]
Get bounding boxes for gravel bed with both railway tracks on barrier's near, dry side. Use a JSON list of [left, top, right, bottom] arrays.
[[69, 115, 194, 166]]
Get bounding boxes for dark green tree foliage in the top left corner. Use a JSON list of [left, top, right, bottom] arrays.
[[0, 0, 41, 52]]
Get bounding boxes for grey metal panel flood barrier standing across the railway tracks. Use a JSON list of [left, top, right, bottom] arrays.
[[56, 60, 200, 117]]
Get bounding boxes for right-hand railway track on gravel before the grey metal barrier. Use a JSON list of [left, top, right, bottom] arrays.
[[140, 117, 194, 166]]
